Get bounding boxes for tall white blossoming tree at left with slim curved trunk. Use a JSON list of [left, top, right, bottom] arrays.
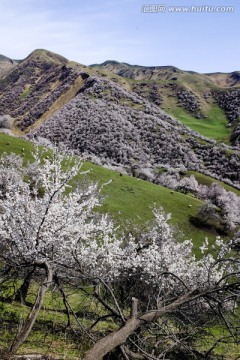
[[0, 150, 118, 353]]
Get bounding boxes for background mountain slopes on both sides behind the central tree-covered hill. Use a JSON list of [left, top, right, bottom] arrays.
[[0, 49, 240, 145]]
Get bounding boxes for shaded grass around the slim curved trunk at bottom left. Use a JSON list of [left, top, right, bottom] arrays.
[[0, 283, 115, 360]]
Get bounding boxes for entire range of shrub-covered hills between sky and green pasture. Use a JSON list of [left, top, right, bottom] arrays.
[[0, 49, 240, 187]]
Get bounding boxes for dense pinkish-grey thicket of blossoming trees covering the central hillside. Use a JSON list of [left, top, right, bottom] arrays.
[[29, 78, 240, 186]]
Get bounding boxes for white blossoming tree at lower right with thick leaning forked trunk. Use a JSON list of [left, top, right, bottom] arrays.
[[81, 210, 240, 360]]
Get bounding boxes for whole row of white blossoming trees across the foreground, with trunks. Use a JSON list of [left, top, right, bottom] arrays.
[[0, 151, 240, 360]]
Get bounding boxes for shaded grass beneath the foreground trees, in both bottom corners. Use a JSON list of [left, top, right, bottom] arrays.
[[0, 284, 240, 360]]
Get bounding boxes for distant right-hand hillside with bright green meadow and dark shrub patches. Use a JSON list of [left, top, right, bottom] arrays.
[[91, 61, 240, 145]]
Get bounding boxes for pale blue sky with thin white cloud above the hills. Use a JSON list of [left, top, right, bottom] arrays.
[[0, 0, 240, 73]]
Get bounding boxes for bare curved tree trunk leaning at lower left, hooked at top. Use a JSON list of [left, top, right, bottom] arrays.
[[9, 261, 53, 354]]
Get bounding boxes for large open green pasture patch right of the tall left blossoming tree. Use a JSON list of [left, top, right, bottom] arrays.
[[86, 166, 208, 250]]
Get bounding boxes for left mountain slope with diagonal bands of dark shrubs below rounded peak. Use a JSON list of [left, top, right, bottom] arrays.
[[0, 50, 86, 131]]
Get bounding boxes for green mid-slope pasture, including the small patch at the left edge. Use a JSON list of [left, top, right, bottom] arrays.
[[0, 134, 235, 253]]
